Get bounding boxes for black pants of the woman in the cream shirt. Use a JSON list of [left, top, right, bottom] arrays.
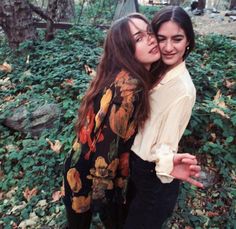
[[124, 153, 179, 229]]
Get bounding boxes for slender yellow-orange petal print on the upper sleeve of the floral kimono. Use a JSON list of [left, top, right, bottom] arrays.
[[94, 89, 112, 131]]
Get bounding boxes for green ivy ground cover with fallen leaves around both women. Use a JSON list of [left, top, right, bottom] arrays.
[[0, 4, 236, 229]]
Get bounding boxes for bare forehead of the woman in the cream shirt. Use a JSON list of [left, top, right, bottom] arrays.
[[157, 21, 186, 36]]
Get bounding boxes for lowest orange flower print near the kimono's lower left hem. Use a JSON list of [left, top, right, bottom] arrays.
[[72, 196, 91, 213]]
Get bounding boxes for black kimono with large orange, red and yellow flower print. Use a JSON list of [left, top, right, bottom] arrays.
[[64, 71, 139, 229]]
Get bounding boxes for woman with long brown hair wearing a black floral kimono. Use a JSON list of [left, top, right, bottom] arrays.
[[64, 14, 160, 229]]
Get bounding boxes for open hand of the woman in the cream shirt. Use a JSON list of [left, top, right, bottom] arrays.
[[170, 153, 203, 188]]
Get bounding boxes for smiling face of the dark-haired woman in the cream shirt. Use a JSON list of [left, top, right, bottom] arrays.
[[157, 21, 189, 68]]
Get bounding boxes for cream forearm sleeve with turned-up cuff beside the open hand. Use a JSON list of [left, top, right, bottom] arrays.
[[155, 144, 175, 183]]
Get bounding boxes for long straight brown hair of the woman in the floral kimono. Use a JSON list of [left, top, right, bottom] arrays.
[[76, 13, 159, 131]]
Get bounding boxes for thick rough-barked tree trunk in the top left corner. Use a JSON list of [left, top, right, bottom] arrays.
[[0, 0, 37, 48]]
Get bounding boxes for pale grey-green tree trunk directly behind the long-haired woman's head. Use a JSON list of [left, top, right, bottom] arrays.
[[113, 0, 139, 20]]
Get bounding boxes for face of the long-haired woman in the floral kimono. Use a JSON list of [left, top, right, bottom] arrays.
[[129, 18, 160, 70]]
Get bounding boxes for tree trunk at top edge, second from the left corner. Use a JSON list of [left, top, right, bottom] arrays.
[[47, 0, 75, 22]]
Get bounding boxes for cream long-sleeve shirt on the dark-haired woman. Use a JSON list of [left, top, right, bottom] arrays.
[[132, 62, 196, 183]]
